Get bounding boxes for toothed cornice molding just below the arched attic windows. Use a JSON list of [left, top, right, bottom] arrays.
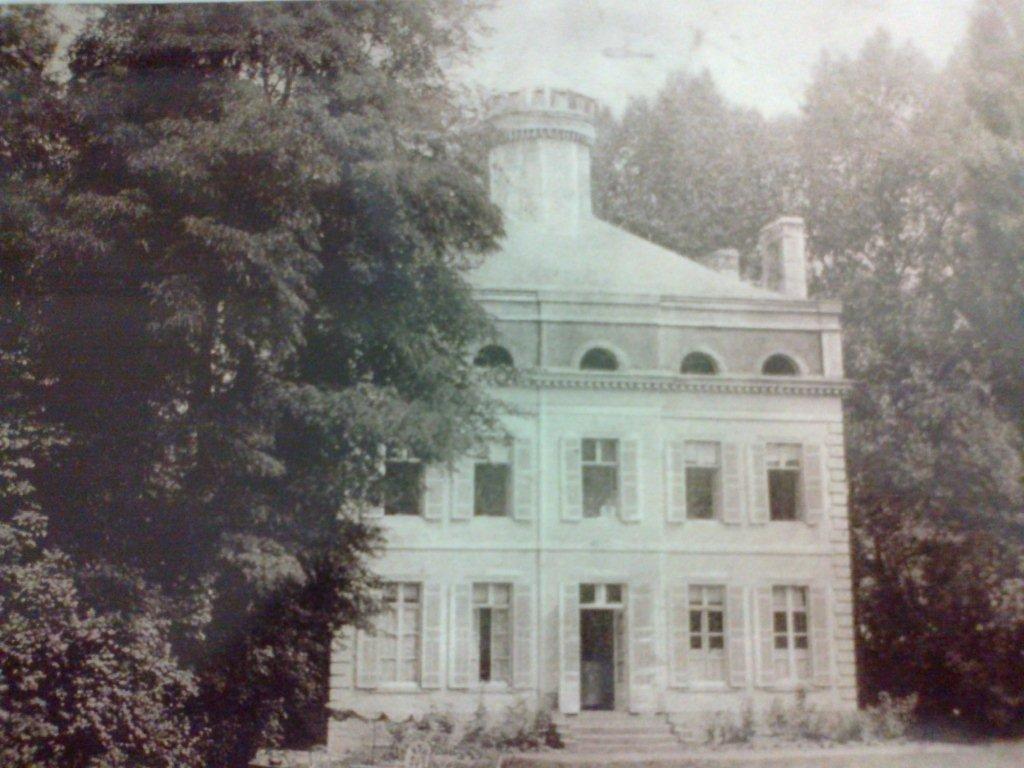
[[498, 369, 853, 397]]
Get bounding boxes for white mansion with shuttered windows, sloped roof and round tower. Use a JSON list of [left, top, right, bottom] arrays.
[[330, 90, 856, 749]]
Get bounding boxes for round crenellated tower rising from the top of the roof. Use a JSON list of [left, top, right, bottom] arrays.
[[488, 88, 597, 226]]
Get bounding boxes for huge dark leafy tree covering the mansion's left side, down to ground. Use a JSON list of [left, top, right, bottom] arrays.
[[0, 0, 500, 765]]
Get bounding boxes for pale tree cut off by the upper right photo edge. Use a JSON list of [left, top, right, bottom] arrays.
[[949, 0, 1024, 428]]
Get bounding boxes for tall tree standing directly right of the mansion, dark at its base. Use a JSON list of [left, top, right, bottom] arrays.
[[800, 27, 1024, 726]]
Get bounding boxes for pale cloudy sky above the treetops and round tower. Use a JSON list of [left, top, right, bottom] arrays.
[[460, 0, 974, 116]]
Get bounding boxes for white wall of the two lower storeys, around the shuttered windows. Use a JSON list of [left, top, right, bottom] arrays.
[[330, 388, 856, 753]]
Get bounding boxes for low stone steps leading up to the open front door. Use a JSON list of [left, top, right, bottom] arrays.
[[555, 712, 681, 756]]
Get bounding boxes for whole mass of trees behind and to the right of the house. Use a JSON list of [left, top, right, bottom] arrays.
[[601, 0, 1024, 730]]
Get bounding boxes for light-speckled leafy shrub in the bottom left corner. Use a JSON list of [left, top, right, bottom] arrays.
[[0, 515, 200, 768]]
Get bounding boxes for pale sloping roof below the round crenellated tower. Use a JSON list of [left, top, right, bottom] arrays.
[[466, 216, 787, 300]]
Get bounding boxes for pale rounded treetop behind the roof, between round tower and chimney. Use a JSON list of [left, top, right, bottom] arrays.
[[595, 72, 794, 264]]
